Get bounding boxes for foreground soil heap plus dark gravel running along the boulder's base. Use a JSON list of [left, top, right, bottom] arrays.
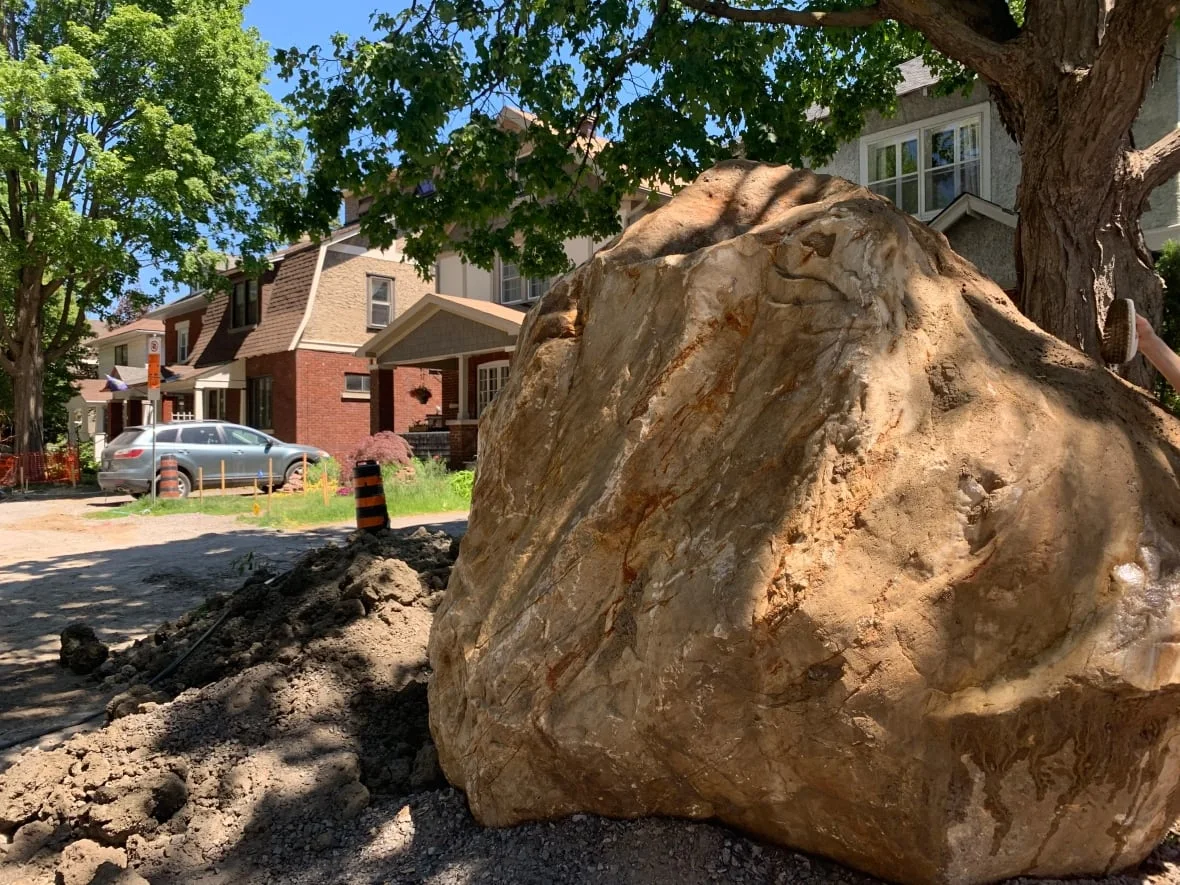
[[0, 530, 1180, 885]]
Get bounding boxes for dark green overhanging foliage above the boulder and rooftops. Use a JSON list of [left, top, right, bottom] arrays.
[[277, 0, 1023, 274]]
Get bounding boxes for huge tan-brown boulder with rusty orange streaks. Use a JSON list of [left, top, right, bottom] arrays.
[[430, 163, 1180, 883]]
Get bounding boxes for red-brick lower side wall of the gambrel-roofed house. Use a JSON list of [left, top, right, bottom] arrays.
[[294, 350, 369, 458]]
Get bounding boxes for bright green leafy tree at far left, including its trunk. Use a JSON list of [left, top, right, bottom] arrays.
[[0, 0, 302, 450]]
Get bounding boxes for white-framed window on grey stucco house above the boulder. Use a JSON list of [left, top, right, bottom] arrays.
[[860, 107, 991, 219]]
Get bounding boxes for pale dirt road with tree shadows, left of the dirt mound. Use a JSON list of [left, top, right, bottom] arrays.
[[0, 493, 466, 766]]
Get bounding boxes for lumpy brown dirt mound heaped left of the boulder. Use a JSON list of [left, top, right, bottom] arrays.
[[0, 530, 452, 883]]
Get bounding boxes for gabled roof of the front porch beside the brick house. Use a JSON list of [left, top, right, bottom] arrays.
[[356, 294, 525, 369]]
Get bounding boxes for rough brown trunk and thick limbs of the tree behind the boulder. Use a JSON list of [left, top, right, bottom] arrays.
[[684, 0, 1180, 382]]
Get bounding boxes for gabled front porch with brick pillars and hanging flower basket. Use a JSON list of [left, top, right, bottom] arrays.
[[358, 294, 525, 467]]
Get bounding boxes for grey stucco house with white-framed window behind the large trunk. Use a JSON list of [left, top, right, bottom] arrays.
[[817, 37, 1180, 291]]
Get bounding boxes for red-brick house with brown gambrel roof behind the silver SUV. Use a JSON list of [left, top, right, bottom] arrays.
[[98, 224, 441, 457]]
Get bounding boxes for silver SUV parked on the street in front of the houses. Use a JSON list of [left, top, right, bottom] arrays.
[[98, 421, 329, 498]]
